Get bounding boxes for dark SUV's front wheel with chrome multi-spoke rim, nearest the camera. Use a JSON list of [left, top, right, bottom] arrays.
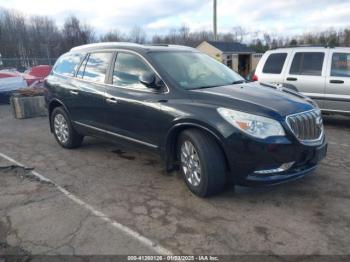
[[177, 129, 226, 197]]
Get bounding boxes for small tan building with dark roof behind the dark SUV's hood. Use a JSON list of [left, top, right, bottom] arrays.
[[197, 41, 263, 77]]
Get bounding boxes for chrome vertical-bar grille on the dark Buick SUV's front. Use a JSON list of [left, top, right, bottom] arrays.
[[287, 110, 323, 142]]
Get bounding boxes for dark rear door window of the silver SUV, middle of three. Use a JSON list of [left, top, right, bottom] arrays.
[[289, 52, 324, 76]]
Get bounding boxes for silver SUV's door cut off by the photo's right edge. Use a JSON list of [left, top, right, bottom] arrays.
[[324, 49, 350, 112]]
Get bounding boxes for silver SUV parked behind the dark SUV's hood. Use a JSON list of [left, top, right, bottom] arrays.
[[253, 47, 350, 115]]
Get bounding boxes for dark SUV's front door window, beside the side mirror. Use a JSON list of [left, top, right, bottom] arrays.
[[113, 53, 152, 88]]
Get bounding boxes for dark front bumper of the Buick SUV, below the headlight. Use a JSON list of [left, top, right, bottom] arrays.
[[226, 135, 328, 186]]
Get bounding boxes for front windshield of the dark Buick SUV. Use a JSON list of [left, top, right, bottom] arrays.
[[151, 52, 244, 89]]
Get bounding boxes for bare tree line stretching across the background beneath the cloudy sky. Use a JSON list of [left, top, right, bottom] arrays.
[[0, 9, 350, 63]]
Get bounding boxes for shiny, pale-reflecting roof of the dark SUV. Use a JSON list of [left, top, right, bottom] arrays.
[[71, 42, 197, 52]]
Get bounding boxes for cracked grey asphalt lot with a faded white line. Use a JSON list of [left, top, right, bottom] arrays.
[[0, 106, 350, 255]]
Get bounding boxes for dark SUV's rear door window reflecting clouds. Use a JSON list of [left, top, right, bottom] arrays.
[[83, 52, 112, 83]]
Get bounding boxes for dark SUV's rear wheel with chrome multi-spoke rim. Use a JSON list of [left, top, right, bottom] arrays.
[[50, 107, 84, 149]]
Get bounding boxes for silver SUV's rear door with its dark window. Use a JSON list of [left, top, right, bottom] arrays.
[[284, 49, 329, 108]]
